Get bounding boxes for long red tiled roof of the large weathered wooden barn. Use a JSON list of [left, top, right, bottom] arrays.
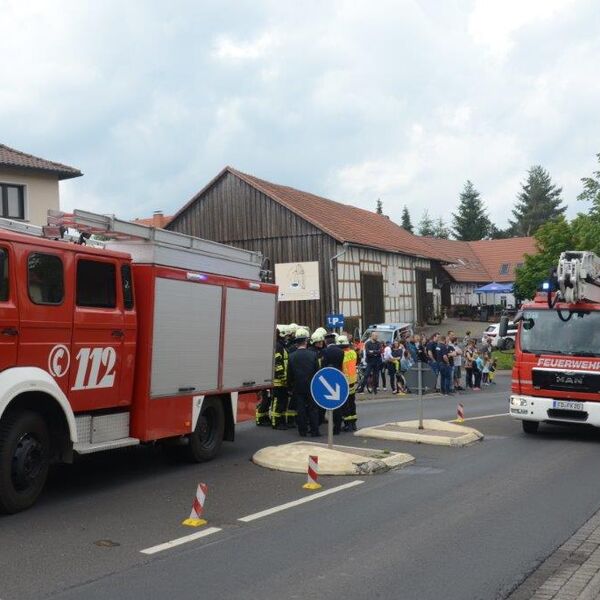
[[173, 167, 446, 260]]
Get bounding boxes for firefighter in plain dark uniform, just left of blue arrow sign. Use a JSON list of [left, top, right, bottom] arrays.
[[288, 327, 321, 437]]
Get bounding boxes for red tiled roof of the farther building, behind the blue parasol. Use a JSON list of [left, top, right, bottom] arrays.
[[427, 237, 537, 283]]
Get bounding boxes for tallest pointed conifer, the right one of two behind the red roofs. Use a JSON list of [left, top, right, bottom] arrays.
[[510, 165, 567, 236]]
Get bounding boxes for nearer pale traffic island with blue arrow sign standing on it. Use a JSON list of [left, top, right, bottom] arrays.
[[252, 442, 415, 475]]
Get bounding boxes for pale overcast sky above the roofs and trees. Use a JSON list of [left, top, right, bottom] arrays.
[[0, 0, 600, 226]]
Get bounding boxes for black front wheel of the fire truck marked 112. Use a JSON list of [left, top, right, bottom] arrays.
[[0, 411, 50, 513]]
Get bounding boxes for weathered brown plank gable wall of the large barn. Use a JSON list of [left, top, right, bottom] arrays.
[[169, 173, 337, 329]]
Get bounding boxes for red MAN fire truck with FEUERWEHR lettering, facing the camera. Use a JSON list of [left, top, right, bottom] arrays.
[[500, 252, 600, 433]]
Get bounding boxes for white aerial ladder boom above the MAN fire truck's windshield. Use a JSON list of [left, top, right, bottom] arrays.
[[556, 251, 600, 304]]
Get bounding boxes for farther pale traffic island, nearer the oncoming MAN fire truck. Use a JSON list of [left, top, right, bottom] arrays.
[[354, 419, 483, 447]]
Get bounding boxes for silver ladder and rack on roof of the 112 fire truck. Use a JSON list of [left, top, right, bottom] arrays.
[[46, 210, 266, 281]]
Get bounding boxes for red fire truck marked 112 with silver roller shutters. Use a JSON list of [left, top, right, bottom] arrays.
[[0, 211, 277, 513]]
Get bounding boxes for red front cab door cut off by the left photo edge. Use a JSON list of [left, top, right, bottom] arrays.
[[0, 242, 19, 371]]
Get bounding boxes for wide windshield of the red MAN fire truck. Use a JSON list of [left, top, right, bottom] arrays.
[[521, 310, 600, 356]]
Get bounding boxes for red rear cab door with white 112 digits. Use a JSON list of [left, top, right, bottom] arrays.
[[69, 254, 125, 412]]
